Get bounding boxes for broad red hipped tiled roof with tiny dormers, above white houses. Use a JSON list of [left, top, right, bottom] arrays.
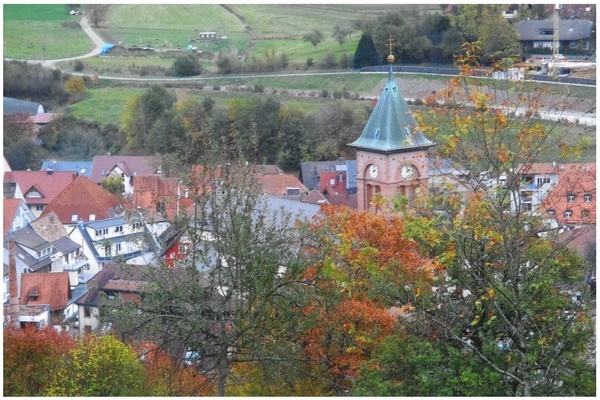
[[42, 175, 131, 224]]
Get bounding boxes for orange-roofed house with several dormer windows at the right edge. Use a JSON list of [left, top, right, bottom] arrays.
[[542, 164, 596, 228]]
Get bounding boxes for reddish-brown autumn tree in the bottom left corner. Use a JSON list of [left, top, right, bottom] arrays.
[[2, 326, 75, 397]]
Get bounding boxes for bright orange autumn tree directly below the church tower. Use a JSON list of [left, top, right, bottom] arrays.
[[303, 206, 435, 394]]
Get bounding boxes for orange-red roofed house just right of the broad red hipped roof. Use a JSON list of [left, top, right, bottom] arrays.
[[132, 175, 193, 219]]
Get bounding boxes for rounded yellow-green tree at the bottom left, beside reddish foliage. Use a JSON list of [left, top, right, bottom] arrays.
[[45, 335, 145, 396]]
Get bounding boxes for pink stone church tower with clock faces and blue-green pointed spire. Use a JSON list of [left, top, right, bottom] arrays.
[[349, 40, 435, 211]]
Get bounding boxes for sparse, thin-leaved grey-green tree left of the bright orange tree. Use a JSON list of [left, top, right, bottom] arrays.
[[102, 162, 318, 395]]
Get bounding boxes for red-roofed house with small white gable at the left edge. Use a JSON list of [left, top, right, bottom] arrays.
[[4, 170, 77, 218]]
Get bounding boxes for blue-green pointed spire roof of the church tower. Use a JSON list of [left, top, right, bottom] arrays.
[[349, 55, 435, 154]]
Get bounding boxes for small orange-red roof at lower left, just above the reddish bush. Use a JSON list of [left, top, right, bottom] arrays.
[[21, 272, 71, 311]]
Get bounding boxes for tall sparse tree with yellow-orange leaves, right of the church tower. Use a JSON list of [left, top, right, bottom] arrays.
[[398, 45, 595, 396]]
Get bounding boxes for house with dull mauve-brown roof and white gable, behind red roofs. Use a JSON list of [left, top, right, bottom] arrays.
[[90, 156, 159, 196]]
